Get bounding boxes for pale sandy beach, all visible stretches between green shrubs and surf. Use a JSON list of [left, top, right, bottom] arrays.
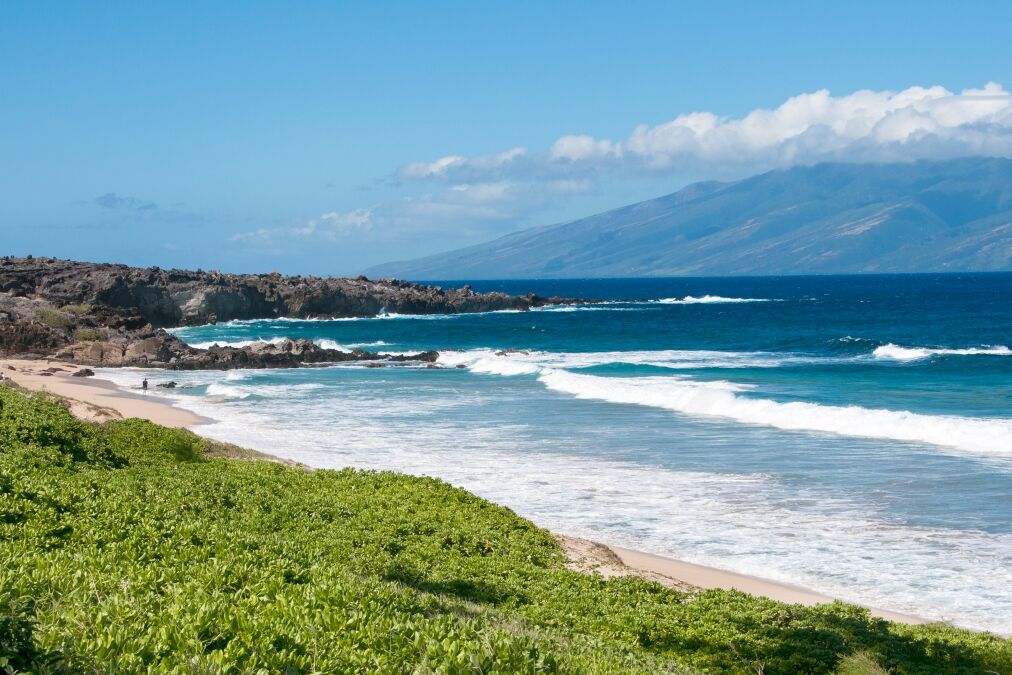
[[0, 358, 933, 624]]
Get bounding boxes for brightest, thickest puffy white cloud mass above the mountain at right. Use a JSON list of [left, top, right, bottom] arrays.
[[619, 83, 1012, 169]]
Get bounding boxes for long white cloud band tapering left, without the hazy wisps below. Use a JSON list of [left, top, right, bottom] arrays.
[[400, 82, 1012, 182]]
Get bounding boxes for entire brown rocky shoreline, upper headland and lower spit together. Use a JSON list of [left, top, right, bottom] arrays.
[[0, 257, 572, 370]]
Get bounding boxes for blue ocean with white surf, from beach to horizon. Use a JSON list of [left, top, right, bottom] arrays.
[[100, 274, 1012, 634]]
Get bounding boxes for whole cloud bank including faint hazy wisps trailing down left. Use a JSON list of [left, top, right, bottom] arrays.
[[234, 83, 1012, 252]]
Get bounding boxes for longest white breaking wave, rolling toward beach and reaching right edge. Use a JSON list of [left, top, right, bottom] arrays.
[[538, 368, 1012, 456]]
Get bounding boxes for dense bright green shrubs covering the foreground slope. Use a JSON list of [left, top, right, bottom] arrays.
[[0, 387, 1012, 673]]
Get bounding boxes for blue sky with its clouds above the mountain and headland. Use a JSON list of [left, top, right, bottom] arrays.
[[0, 0, 1012, 274]]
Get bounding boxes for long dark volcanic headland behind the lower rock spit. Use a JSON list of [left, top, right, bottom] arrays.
[[0, 258, 562, 329]]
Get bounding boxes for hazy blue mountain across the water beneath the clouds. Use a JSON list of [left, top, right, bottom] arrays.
[[367, 158, 1012, 279]]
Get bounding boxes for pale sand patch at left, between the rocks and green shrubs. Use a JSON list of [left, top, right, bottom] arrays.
[[0, 358, 206, 429]]
